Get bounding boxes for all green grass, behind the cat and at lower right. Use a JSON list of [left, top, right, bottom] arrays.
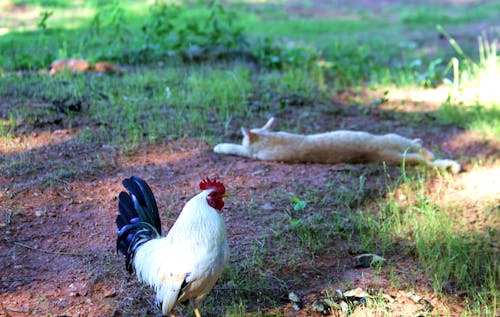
[[0, 0, 500, 316]]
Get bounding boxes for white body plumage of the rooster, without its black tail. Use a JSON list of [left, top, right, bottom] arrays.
[[119, 175, 229, 316]]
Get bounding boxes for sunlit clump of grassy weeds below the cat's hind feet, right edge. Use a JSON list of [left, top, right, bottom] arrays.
[[356, 170, 500, 312]]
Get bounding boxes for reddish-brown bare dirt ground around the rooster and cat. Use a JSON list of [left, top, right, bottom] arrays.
[[0, 1, 500, 317]]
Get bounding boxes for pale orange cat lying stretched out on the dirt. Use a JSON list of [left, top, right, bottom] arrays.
[[214, 118, 460, 173]]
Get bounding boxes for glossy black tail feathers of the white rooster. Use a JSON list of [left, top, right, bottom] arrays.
[[116, 176, 161, 272]]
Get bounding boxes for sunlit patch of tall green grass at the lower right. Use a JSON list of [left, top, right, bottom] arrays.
[[355, 172, 500, 316]]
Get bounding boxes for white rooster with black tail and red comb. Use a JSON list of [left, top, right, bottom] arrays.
[[116, 176, 229, 317]]
